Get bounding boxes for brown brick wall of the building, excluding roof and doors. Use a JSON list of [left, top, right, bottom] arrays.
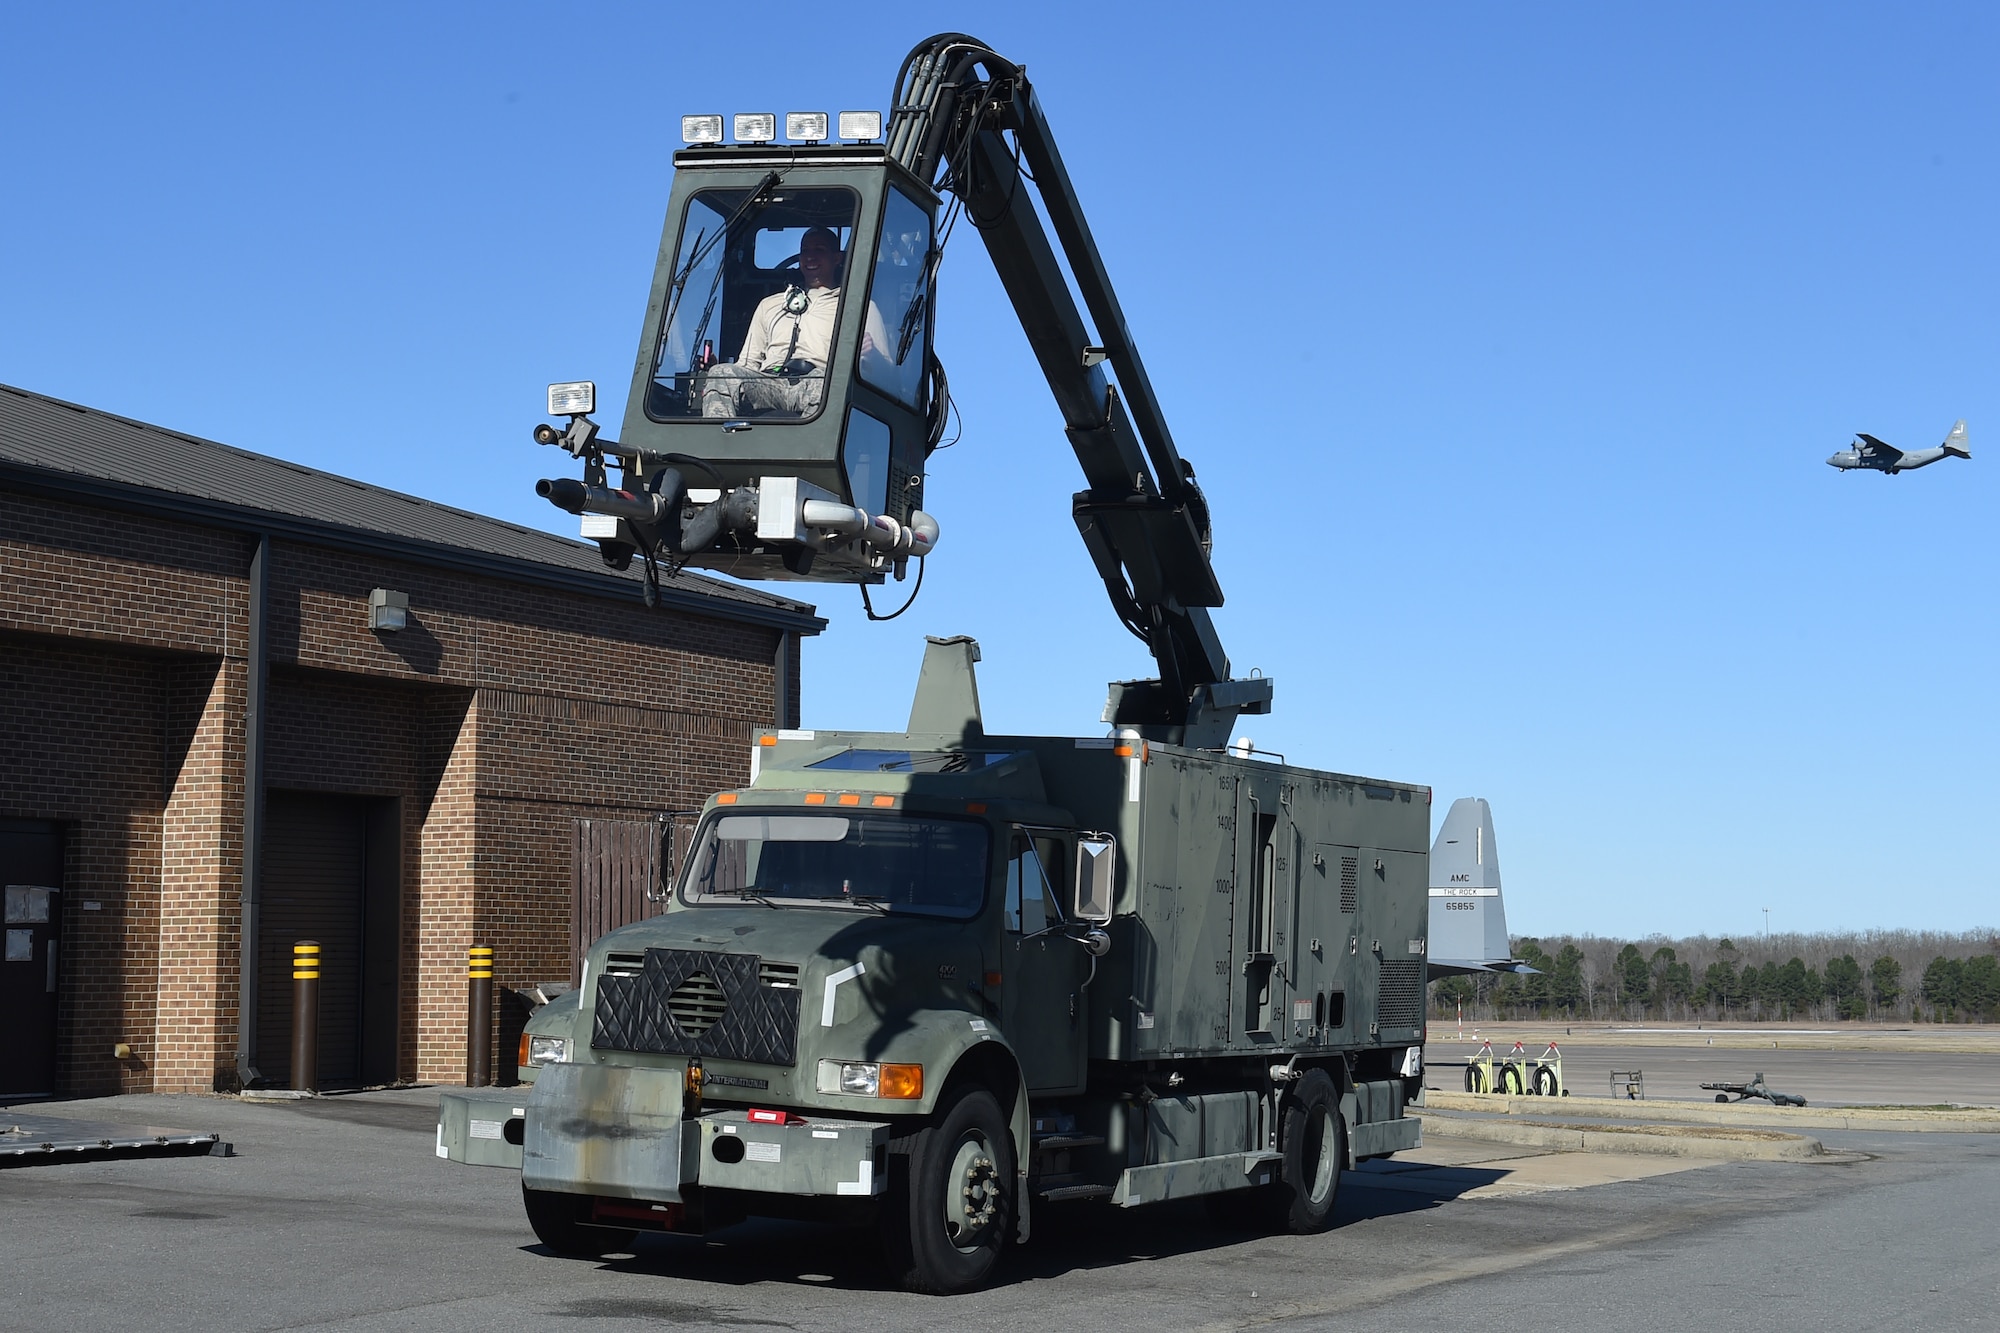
[[0, 482, 798, 1093]]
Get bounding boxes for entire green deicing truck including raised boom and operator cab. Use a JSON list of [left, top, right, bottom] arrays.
[[438, 34, 1430, 1291]]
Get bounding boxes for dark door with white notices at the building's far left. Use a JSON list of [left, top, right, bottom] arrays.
[[0, 819, 62, 1101]]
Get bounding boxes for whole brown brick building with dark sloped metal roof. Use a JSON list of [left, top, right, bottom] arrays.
[[0, 388, 824, 1095]]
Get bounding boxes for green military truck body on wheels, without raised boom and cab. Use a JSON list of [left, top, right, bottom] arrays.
[[438, 638, 1430, 1291]]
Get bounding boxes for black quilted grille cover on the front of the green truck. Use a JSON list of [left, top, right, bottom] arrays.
[[590, 949, 798, 1065]]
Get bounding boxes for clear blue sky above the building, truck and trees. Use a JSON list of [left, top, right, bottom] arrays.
[[0, 4, 2000, 935]]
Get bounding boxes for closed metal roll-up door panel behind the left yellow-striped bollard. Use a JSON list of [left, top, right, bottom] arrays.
[[256, 791, 368, 1087]]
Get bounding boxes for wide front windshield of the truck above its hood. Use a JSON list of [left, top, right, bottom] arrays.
[[680, 811, 988, 919]]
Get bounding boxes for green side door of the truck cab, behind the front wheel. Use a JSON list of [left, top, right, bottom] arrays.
[[1000, 829, 1088, 1093]]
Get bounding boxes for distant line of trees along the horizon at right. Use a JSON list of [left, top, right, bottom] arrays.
[[1430, 931, 2000, 1023]]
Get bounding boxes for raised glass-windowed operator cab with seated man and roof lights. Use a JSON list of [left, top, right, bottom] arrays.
[[538, 118, 944, 582]]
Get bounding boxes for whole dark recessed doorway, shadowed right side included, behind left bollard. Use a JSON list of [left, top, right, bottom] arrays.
[[256, 791, 400, 1087]]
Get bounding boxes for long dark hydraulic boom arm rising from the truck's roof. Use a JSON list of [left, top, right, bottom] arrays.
[[888, 32, 1272, 747]]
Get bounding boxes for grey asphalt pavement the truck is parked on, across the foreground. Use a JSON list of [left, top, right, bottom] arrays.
[[0, 1089, 2000, 1333]]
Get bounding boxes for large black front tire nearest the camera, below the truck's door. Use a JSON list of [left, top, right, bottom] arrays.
[[884, 1087, 1016, 1295]]
